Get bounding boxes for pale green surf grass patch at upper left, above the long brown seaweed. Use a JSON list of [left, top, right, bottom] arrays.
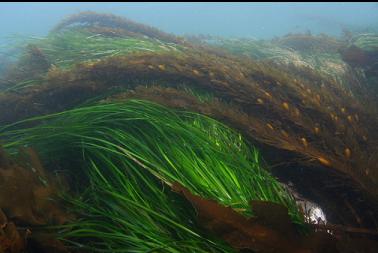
[[35, 28, 179, 68]]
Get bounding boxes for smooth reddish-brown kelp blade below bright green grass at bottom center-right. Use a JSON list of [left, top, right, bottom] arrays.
[[172, 182, 339, 253]]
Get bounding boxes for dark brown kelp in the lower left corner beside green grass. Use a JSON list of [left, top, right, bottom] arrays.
[[0, 147, 73, 253]]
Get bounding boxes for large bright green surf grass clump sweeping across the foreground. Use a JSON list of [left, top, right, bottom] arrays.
[[0, 100, 303, 252]]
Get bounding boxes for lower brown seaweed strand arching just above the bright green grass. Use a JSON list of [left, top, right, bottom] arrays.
[[105, 86, 376, 192]]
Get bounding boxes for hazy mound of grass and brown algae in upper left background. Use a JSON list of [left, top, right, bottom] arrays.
[[0, 13, 183, 91]]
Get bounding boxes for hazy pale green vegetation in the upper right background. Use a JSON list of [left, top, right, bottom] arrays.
[[187, 32, 378, 111]]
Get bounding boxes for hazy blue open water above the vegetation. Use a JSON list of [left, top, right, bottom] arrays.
[[0, 2, 378, 39]]
